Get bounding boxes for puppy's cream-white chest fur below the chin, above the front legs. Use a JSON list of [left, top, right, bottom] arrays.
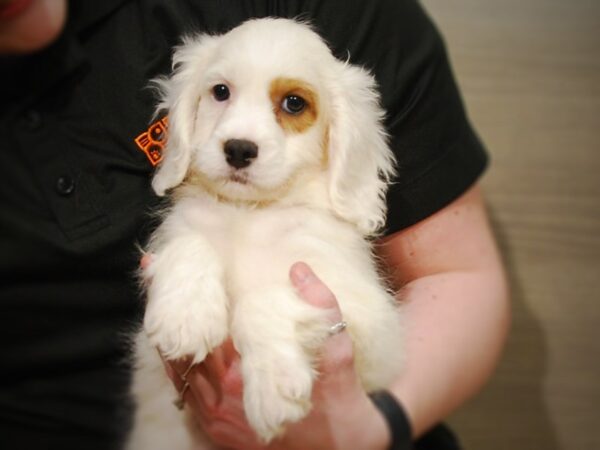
[[164, 193, 370, 301]]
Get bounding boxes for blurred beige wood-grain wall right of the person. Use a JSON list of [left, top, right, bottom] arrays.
[[422, 0, 600, 450]]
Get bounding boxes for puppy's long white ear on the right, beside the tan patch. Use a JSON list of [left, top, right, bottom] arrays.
[[328, 61, 394, 235]]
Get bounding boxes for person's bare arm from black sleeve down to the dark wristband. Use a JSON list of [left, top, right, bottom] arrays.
[[380, 188, 509, 436]]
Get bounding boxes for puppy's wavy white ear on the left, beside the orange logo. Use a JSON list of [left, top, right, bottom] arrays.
[[152, 34, 218, 196]]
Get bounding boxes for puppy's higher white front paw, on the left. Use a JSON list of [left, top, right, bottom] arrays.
[[144, 278, 228, 362]]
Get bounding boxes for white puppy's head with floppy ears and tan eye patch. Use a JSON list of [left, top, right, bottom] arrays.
[[153, 19, 392, 233]]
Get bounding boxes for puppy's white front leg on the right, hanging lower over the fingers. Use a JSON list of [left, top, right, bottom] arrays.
[[232, 286, 328, 442]]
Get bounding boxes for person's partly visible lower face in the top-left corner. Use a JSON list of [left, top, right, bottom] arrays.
[[0, 0, 67, 54]]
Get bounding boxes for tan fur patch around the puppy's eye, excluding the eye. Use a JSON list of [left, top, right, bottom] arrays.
[[269, 78, 319, 133]]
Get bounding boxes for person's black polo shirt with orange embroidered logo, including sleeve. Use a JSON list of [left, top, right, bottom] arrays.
[[0, 0, 486, 450]]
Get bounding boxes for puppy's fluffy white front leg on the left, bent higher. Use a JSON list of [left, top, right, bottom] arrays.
[[144, 234, 228, 362]]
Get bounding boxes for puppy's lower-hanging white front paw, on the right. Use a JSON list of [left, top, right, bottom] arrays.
[[242, 355, 314, 442]]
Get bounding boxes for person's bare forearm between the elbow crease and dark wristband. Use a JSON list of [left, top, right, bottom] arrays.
[[392, 270, 509, 436]]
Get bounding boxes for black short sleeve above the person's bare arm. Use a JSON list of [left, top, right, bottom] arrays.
[[302, 0, 488, 234]]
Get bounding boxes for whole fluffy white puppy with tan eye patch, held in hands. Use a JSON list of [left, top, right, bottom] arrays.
[[129, 18, 400, 450]]
